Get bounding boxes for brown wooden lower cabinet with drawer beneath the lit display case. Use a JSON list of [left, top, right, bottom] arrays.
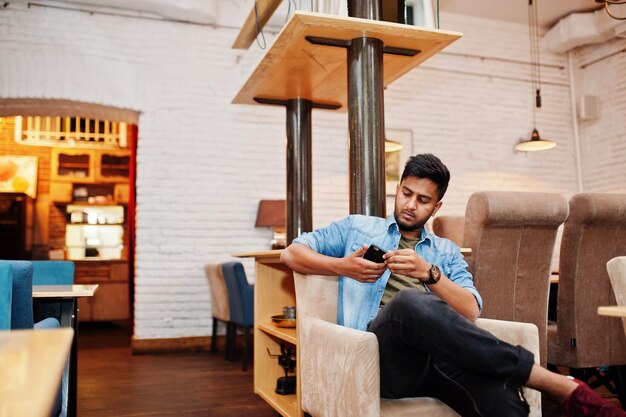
[[75, 261, 130, 321]]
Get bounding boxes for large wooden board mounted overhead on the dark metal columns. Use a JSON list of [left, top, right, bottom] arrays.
[[233, 12, 462, 111]]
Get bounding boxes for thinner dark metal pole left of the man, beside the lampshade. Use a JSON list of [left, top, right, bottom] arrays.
[[287, 98, 313, 245]]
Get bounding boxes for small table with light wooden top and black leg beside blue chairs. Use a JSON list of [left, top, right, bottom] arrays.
[[33, 284, 98, 417]]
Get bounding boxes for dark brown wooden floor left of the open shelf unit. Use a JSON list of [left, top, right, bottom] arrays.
[[78, 323, 279, 417]]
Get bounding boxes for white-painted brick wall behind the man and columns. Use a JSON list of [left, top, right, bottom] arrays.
[[0, 4, 626, 339]]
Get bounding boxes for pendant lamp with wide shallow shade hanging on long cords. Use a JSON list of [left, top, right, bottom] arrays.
[[515, 0, 556, 152]]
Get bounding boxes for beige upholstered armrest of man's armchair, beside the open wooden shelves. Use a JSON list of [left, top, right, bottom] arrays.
[[298, 317, 380, 417]]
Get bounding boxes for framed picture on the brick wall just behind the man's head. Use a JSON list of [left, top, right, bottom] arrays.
[[385, 129, 413, 195]]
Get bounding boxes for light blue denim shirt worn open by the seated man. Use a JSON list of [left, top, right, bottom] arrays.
[[294, 215, 483, 330]]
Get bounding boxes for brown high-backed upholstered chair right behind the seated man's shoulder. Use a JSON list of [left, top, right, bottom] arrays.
[[463, 192, 568, 365]]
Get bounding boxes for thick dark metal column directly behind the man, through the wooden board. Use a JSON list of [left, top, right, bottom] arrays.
[[348, 0, 385, 217]]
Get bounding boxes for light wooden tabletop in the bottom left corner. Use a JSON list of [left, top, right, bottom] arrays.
[[0, 328, 74, 417]]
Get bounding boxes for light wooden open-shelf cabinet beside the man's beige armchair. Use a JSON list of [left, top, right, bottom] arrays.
[[235, 250, 304, 417]]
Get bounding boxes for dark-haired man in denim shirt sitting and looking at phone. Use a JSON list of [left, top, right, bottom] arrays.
[[281, 154, 626, 417]]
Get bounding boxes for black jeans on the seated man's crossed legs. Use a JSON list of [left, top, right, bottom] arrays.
[[368, 289, 534, 417]]
